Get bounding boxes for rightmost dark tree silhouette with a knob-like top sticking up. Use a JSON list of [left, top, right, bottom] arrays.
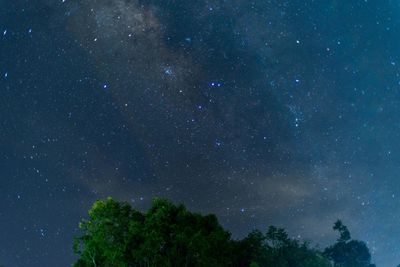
[[324, 220, 375, 267]]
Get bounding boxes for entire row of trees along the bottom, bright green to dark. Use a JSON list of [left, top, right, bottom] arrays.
[[74, 198, 374, 267]]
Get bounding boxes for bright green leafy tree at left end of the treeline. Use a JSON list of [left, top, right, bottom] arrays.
[[74, 198, 144, 267]]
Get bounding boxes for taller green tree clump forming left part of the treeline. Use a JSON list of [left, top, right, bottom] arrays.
[[74, 198, 234, 267]]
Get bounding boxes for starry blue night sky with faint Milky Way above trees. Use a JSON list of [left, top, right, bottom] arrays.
[[0, 0, 400, 267]]
